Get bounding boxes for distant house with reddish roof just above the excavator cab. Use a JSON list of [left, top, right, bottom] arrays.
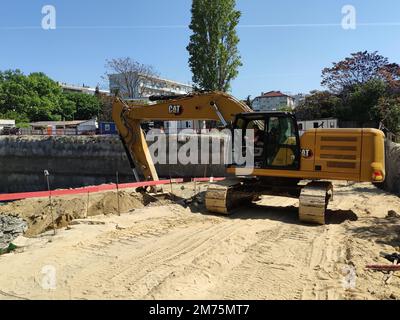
[[252, 91, 295, 111]]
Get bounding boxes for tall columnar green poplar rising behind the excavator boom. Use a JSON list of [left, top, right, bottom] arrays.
[[187, 0, 242, 91]]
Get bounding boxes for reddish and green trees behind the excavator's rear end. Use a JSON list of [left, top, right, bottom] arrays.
[[296, 51, 400, 133]]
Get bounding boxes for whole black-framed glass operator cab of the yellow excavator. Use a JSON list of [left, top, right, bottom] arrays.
[[232, 112, 300, 170]]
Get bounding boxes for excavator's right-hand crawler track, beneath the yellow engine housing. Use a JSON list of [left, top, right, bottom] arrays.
[[299, 181, 333, 225]]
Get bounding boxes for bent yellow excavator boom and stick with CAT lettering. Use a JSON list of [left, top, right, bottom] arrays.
[[112, 92, 252, 181]]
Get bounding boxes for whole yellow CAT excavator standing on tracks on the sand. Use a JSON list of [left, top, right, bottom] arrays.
[[113, 92, 385, 224]]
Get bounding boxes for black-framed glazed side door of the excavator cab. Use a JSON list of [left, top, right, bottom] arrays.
[[265, 114, 300, 170]]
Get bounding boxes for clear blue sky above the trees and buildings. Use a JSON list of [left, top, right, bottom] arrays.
[[0, 0, 400, 98]]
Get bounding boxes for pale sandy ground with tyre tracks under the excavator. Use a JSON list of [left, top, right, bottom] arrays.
[[0, 183, 400, 299]]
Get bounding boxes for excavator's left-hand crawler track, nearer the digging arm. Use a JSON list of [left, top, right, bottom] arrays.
[[205, 179, 257, 215]]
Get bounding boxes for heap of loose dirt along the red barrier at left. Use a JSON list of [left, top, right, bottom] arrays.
[[0, 191, 171, 237]]
